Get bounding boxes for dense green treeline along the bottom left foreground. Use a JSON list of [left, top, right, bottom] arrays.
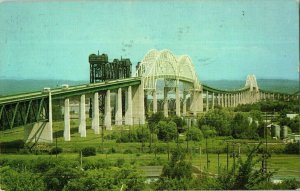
[[0, 158, 145, 191]]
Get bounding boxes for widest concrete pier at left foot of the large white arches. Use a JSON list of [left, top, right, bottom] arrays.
[[132, 81, 145, 124]]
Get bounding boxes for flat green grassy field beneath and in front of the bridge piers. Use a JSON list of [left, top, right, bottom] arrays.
[[0, 119, 300, 179]]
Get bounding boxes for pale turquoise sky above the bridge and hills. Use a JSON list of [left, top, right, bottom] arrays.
[[0, 0, 299, 81]]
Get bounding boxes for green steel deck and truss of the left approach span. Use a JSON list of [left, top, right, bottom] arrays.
[[0, 78, 141, 130]]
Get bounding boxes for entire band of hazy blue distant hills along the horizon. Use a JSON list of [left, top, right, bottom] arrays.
[[0, 79, 299, 96]]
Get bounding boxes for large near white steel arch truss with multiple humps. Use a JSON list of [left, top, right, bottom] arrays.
[[136, 49, 202, 91]]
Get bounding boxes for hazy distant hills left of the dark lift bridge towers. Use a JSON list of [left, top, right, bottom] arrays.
[[0, 80, 88, 96]]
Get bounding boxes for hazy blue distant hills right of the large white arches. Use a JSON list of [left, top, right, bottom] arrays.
[[203, 79, 299, 93]]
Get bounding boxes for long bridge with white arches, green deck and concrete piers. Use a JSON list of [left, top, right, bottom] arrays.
[[0, 50, 299, 142]]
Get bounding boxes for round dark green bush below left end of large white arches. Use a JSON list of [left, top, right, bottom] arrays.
[[157, 121, 177, 142]]
